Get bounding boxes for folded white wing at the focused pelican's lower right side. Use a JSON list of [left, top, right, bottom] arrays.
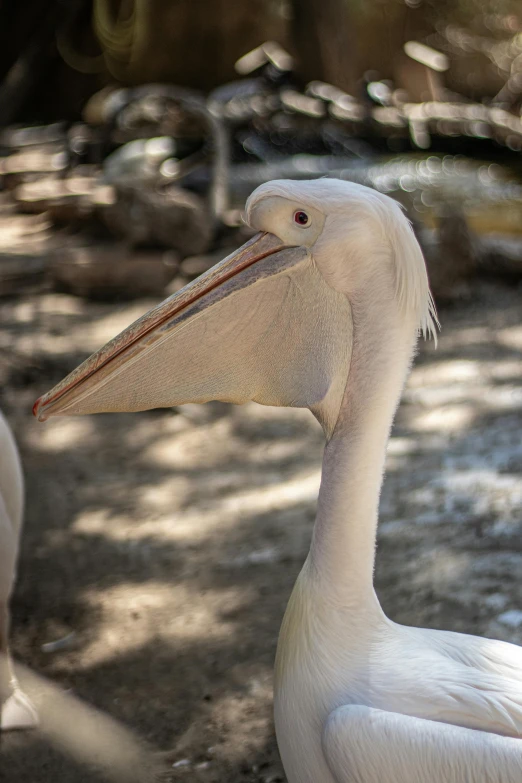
[[323, 705, 522, 783]]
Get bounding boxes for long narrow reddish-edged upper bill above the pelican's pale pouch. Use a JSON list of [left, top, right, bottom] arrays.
[[33, 233, 288, 421]]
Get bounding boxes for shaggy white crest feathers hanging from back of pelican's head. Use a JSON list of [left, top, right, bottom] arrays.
[[388, 202, 440, 346]]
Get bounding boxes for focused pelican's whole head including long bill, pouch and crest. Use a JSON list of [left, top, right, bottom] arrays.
[[30, 179, 434, 436]]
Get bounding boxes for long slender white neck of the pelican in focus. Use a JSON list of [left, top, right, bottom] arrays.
[[309, 292, 416, 607]]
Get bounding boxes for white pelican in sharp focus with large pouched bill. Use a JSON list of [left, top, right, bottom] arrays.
[[35, 180, 522, 783]]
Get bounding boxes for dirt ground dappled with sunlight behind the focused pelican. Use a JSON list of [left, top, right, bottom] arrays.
[[0, 272, 522, 783]]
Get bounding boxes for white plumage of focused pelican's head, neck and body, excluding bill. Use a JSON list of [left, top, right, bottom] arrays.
[[244, 180, 522, 783]]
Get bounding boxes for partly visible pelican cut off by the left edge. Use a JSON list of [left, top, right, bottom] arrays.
[[0, 413, 38, 731]]
